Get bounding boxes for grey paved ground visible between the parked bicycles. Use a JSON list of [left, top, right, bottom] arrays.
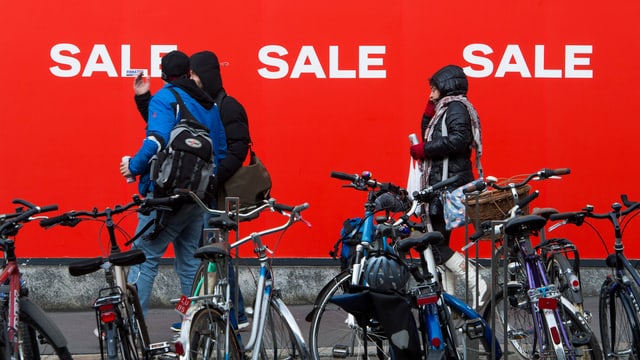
[[42, 297, 600, 360]]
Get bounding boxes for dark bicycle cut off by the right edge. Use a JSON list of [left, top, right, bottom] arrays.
[[550, 195, 640, 359]]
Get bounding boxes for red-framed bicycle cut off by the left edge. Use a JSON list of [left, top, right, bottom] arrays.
[[0, 199, 72, 360]]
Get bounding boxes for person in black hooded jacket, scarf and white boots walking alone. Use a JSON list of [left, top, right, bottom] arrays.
[[410, 65, 488, 307]]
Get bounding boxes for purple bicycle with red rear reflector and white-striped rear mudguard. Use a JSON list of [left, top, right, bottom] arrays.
[[470, 169, 602, 359]]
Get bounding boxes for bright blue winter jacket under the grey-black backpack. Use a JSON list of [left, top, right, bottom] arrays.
[[129, 84, 227, 195]]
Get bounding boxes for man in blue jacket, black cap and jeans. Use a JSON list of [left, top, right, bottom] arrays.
[[120, 50, 226, 314]]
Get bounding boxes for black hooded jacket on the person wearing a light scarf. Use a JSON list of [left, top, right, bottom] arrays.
[[422, 65, 474, 188]]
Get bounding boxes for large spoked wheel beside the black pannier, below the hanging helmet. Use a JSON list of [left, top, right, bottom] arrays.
[[309, 271, 390, 360]]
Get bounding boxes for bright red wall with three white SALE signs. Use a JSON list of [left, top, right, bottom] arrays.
[[0, 0, 640, 258]]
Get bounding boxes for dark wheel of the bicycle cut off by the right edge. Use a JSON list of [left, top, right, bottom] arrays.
[[599, 278, 640, 359]]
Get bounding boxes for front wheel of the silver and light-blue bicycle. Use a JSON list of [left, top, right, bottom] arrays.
[[260, 295, 309, 360]]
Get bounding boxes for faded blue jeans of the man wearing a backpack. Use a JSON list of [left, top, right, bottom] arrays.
[[127, 204, 203, 315]]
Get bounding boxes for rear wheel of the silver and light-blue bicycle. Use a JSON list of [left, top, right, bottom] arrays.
[[189, 308, 242, 360]]
